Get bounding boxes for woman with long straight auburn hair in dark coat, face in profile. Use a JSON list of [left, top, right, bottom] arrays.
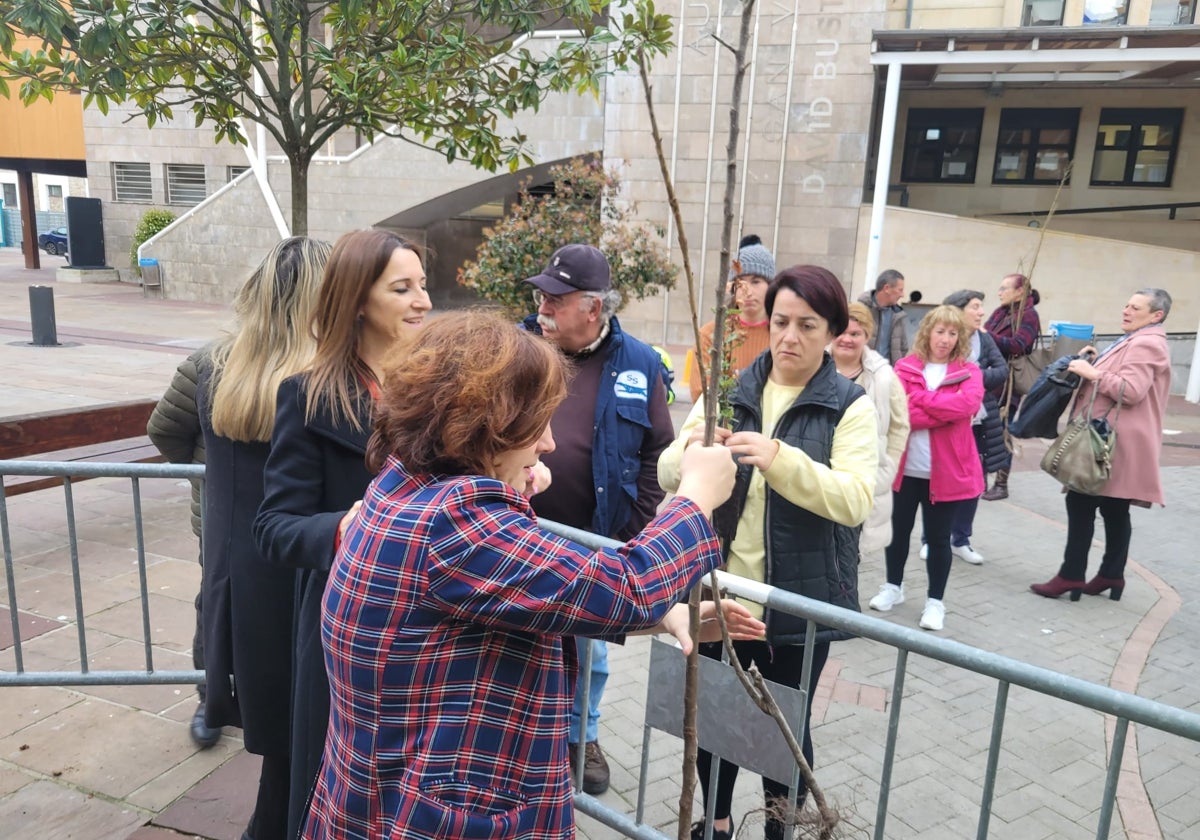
[[254, 230, 431, 838]]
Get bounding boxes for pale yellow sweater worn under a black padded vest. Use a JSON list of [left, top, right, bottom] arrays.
[[659, 379, 878, 618]]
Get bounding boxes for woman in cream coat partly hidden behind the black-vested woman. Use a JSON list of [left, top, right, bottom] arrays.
[[829, 301, 908, 554]]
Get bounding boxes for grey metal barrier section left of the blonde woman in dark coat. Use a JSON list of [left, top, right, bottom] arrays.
[[0, 461, 204, 686]]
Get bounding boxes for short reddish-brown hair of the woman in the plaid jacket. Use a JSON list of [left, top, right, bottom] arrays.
[[367, 310, 570, 475]]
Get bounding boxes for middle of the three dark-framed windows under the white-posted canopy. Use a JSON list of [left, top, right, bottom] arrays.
[[991, 108, 1079, 184]]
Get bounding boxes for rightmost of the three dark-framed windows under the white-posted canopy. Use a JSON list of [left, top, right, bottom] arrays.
[[1092, 108, 1183, 187]]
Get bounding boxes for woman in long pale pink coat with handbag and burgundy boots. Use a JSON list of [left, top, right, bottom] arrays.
[[1030, 288, 1171, 601]]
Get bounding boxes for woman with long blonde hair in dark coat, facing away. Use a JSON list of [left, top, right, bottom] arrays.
[[194, 236, 329, 840]]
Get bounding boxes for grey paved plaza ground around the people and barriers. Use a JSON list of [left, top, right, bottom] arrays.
[[0, 244, 1200, 840]]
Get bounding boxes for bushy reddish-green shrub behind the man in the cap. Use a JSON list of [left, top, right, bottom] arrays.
[[458, 158, 676, 317]]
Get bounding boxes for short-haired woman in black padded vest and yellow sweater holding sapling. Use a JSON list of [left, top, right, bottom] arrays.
[[659, 265, 878, 840]]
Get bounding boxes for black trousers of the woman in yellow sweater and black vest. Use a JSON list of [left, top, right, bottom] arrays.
[[696, 641, 829, 838]]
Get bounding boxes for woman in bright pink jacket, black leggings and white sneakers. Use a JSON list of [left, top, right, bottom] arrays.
[[870, 306, 984, 630]]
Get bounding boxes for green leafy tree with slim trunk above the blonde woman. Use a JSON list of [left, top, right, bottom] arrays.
[[0, 0, 670, 235]]
